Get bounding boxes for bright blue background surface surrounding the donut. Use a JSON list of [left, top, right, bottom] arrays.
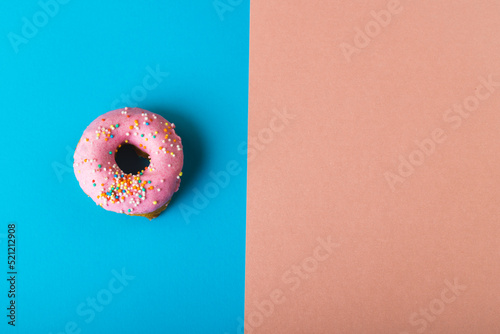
[[0, 0, 249, 334]]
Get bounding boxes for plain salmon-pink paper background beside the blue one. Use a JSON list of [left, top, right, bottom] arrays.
[[246, 0, 500, 333]]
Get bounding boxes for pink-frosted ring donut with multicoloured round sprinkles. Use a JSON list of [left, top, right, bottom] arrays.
[[73, 108, 184, 220]]
